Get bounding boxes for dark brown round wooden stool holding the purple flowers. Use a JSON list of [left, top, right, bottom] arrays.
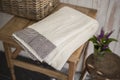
[[86, 53, 120, 80]]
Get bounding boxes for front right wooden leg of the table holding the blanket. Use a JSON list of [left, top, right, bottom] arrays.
[[68, 62, 76, 80]]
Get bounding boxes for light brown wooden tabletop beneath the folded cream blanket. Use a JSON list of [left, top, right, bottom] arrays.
[[0, 3, 97, 61]]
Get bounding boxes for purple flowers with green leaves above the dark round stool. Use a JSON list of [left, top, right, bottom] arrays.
[[89, 28, 117, 54]]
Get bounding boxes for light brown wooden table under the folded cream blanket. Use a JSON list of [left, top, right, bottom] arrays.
[[0, 3, 96, 80]]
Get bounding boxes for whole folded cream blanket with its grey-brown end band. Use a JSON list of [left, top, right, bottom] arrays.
[[13, 7, 98, 70]]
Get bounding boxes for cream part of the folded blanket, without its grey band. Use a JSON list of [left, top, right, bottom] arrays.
[[13, 7, 99, 70]]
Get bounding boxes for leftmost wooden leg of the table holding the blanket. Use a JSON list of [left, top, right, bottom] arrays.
[[3, 42, 16, 80]]
